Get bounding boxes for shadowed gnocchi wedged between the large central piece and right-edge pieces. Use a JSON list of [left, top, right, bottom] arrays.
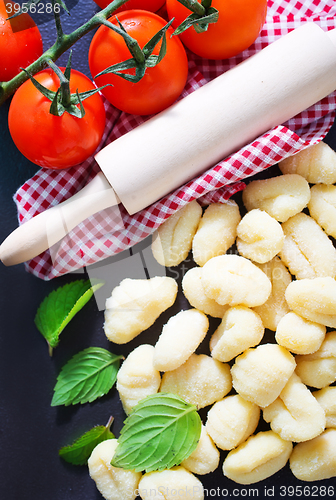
[[253, 257, 292, 331]]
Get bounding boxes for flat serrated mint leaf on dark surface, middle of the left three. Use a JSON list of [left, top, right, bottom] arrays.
[[51, 347, 122, 406]]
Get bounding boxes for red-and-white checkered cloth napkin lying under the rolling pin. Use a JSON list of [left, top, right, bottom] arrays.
[[14, 0, 336, 280]]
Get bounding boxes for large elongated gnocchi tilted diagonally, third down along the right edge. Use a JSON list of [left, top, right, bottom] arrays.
[[279, 213, 336, 279]]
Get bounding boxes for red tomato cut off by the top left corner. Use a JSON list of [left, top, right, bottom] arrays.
[[0, 0, 43, 82]]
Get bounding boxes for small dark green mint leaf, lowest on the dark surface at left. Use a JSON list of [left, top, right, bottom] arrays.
[[58, 417, 114, 465]]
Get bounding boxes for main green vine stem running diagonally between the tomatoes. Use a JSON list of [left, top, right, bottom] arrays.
[[0, 0, 127, 106]]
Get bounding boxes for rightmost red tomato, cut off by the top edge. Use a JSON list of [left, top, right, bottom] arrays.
[[166, 0, 267, 59]]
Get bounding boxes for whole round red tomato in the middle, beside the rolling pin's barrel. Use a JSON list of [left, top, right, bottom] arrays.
[[89, 10, 188, 115]]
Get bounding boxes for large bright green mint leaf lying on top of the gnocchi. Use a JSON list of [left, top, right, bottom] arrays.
[[111, 393, 201, 472]]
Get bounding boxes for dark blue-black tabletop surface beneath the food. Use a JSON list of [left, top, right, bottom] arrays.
[[0, 0, 336, 500]]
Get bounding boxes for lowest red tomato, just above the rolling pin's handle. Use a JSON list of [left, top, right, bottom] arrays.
[[8, 69, 105, 169]]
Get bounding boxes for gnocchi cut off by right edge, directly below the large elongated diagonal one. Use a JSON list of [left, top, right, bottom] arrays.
[[285, 277, 336, 328]]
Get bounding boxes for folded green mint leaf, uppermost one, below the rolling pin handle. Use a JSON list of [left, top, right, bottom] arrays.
[[35, 280, 104, 353]]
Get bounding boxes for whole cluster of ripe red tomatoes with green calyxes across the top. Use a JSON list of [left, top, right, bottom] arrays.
[[0, 0, 267, 169]]
